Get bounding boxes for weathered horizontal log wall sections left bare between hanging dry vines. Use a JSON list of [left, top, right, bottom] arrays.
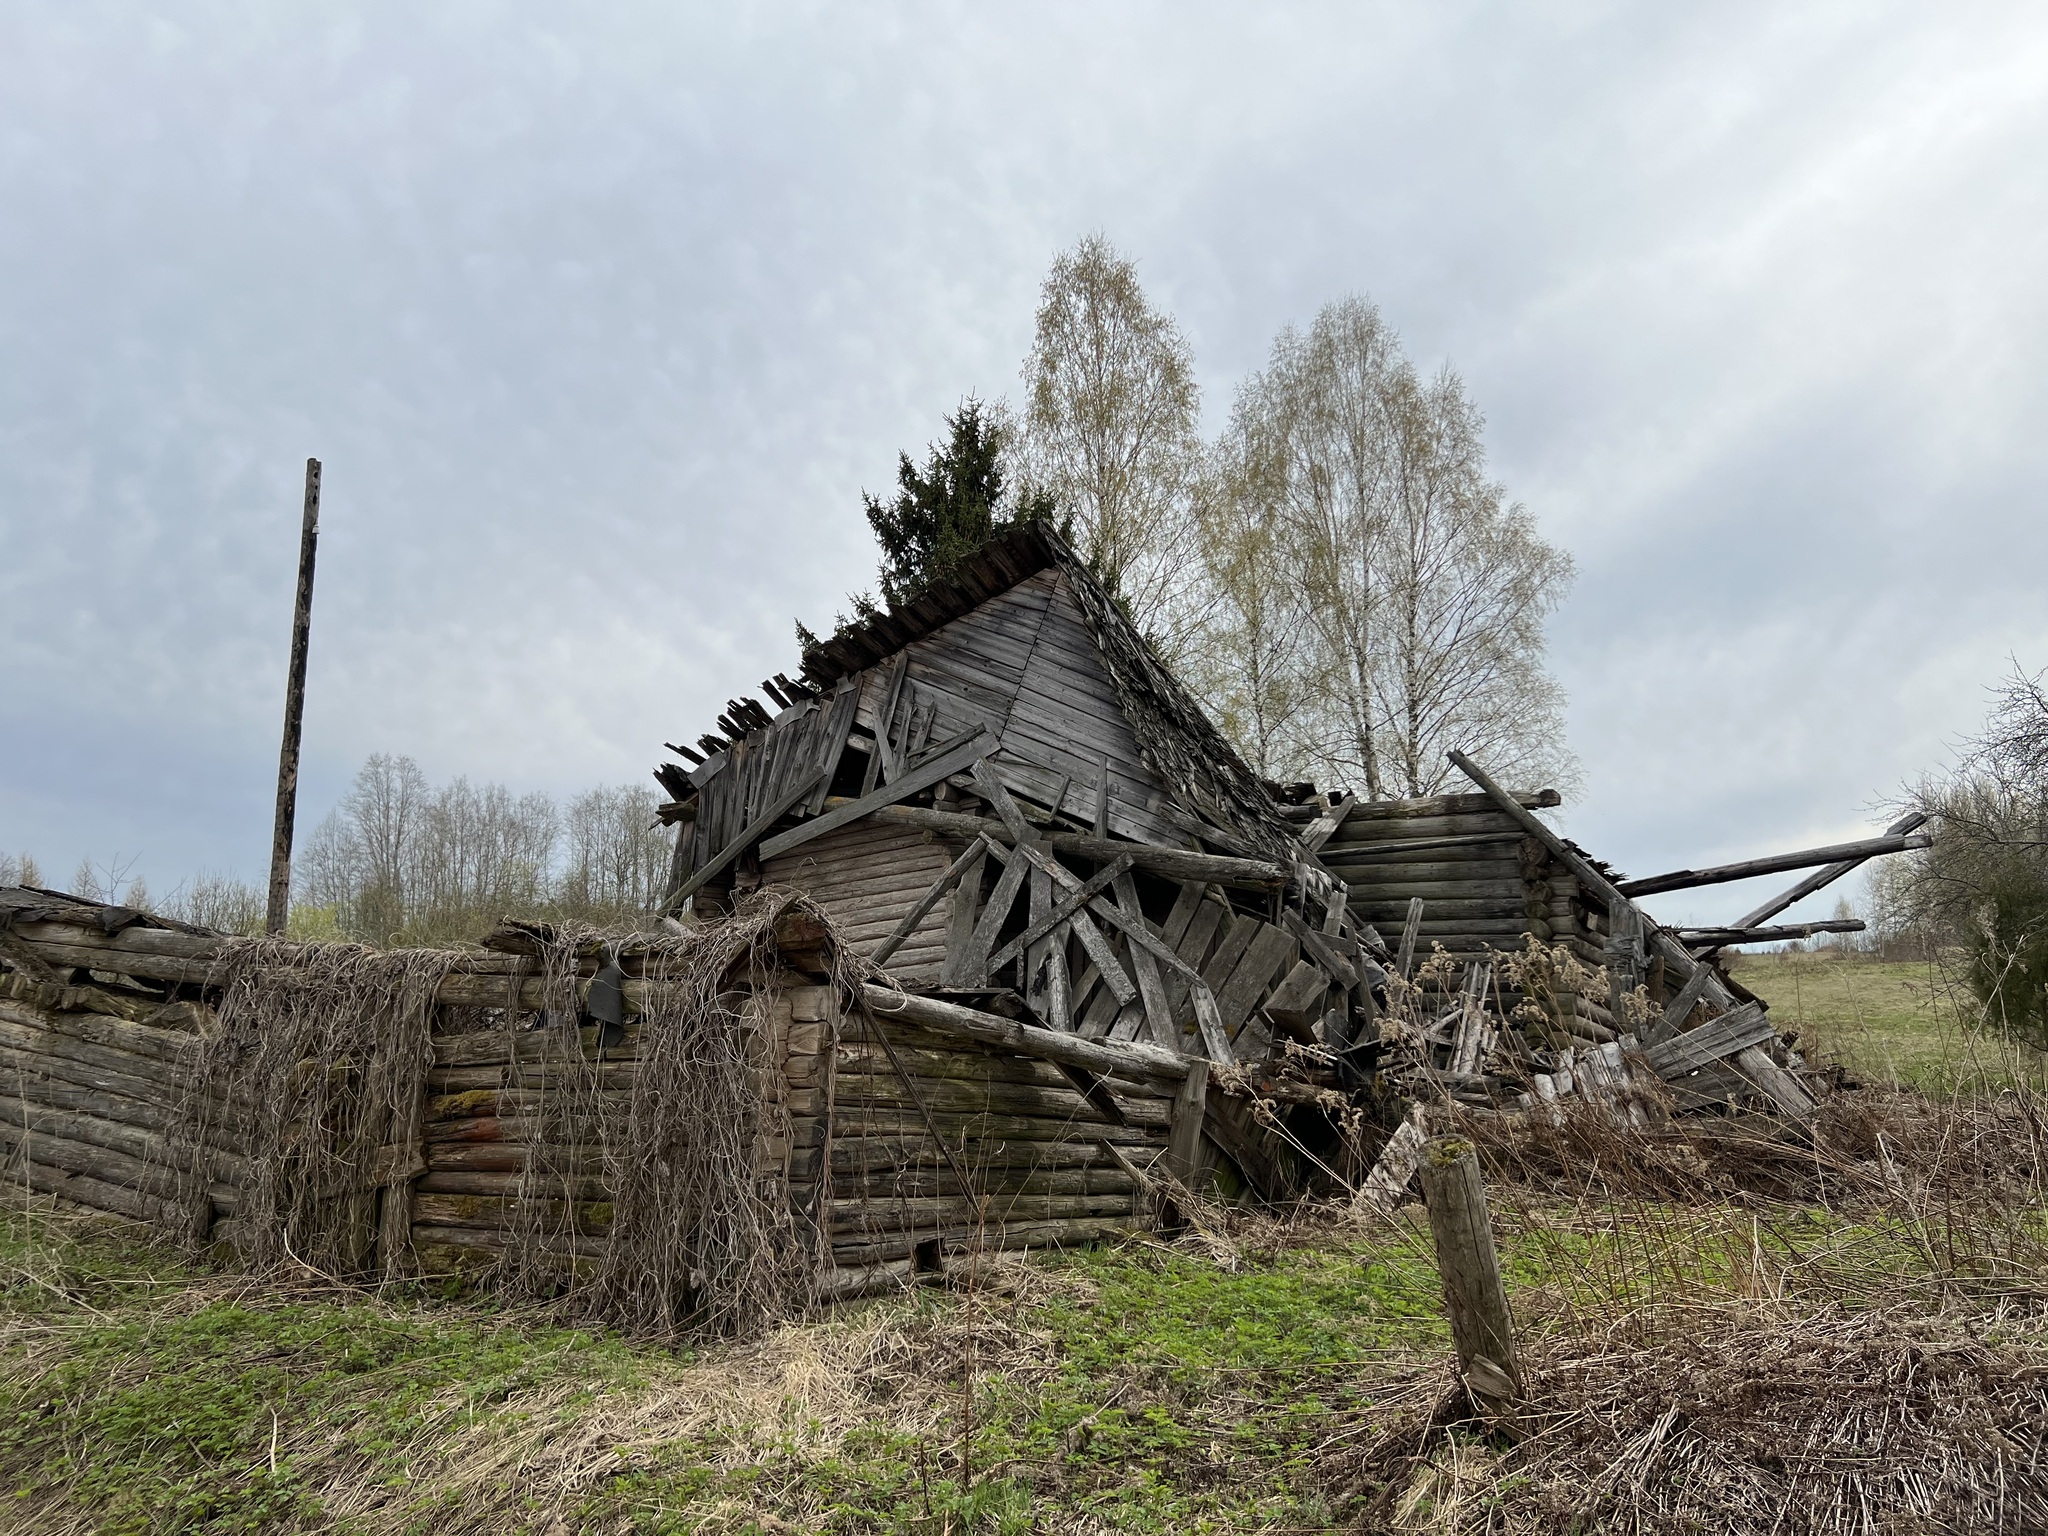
[[0, 921, 1171, 1290]]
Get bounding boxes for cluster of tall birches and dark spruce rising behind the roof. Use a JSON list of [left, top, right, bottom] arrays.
[[823, 236, 1575, 799]]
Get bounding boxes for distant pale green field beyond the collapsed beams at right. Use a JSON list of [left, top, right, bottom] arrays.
[[1735, 950, 2040, 1094]]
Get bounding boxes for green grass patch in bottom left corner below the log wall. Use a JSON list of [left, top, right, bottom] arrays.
[[0, 1212, 635, 1534]]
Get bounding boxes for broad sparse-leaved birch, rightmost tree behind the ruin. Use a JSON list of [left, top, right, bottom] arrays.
[[1233, 297, 1573, 799]]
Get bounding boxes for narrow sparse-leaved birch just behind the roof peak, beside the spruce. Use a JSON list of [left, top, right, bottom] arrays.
[[1024, 236, 1202, 651]]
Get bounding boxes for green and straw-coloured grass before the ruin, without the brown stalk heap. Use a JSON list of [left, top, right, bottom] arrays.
[[0, 1163, 2032, 1536]]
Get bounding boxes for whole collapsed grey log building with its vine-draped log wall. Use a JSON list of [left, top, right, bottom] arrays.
[[0, 526, 1921, 1331]]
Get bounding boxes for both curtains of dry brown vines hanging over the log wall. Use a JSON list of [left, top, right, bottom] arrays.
[[166, 889, 862, 1335]]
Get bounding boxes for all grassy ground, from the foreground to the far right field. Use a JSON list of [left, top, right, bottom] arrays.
[[0, 954, 2048, 1536]]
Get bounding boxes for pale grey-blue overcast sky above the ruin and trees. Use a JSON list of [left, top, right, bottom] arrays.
[[0, 0, 2048, 920]]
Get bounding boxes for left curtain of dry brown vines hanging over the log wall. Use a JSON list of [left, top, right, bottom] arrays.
[[164, 938, 461, 1274]]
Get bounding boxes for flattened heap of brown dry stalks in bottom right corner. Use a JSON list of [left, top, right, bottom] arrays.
[[1333, 1305, 2048, 1536]]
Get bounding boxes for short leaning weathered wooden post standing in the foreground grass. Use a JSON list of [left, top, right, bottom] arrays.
[[1421, 1137, 1522, 1415]]
